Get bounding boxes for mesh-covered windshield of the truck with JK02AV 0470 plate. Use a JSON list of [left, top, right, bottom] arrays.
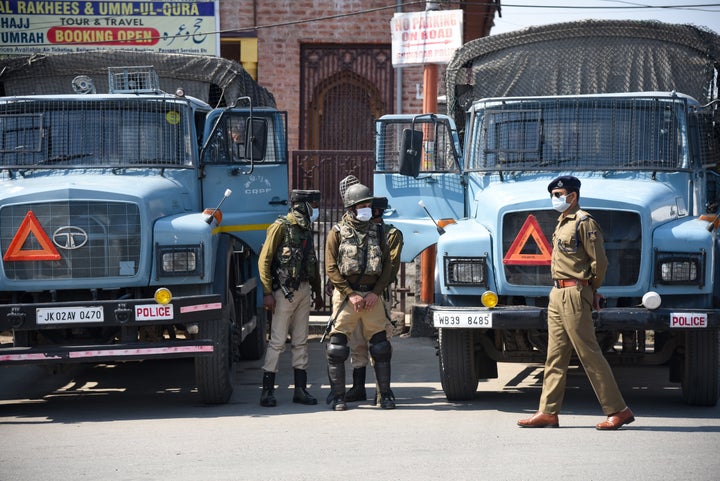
[[0, 98, 197, 168]]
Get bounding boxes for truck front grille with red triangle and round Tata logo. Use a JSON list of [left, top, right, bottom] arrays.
[[0, 201, 141, 280]]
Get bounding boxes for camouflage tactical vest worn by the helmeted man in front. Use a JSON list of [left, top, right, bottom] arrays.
[[333, 224, 385, 277]]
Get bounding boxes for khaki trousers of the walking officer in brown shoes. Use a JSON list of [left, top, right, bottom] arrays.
[[540, 285, 626, 415]]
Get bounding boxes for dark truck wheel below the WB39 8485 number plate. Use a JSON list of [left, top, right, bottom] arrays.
[[439, 329, 478, 401]]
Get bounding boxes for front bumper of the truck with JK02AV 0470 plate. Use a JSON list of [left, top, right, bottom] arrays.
[[0, 294, 222, 364]]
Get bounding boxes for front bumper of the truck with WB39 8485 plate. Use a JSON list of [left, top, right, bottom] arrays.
[[429, 305, 720, 331]]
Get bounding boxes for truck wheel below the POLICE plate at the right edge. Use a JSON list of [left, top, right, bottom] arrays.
[[682, 329, 720, 406]]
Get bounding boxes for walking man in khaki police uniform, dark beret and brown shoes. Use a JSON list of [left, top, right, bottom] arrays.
[[518, 175, 635, 430]]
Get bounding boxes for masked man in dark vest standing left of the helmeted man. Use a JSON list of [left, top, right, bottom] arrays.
[[258, 190, 324, 407]]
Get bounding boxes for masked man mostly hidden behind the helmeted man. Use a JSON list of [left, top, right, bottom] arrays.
[[345, 197, 403, 404]]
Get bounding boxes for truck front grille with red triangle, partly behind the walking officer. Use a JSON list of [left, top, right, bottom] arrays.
[[502, 210, 642, 286]]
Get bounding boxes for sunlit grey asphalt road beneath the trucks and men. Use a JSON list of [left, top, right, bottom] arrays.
[[0, 337, 720, 481]]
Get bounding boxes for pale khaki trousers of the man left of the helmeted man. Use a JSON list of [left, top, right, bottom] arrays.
[[263, 282, 312, 372]]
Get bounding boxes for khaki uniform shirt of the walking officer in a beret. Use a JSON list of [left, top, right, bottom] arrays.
[[550, 206, 608, 291]]
